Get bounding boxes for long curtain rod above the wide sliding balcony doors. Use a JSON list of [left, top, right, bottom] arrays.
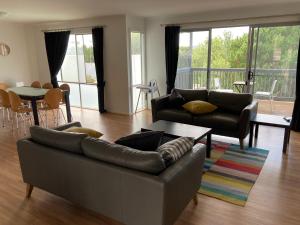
[[160, 13, 300, 27]]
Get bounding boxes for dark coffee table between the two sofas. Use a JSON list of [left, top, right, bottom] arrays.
[[142, 120, 212, 158]]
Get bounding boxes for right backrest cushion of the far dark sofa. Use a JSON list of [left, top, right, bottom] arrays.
[[208, 91, 253, 113]]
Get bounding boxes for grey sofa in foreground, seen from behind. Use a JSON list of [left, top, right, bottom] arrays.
[[17, 122, 205, 225]]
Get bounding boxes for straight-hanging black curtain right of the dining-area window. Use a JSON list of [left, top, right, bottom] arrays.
[[92, 27, 105, 113]]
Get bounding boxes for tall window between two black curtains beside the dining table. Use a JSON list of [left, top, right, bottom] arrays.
[[57, 34, 98, 109]]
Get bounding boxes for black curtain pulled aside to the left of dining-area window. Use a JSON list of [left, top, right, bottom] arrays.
[[45, 31, 70, 88]]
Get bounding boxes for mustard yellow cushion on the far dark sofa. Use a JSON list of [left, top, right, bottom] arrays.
[[182, 100, 218, 114]]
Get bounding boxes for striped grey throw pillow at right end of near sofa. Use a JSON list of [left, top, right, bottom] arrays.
[[157, 137, 194, 166]]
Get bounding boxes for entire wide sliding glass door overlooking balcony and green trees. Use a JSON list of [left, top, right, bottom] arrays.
[[175, 25, 300, 116]]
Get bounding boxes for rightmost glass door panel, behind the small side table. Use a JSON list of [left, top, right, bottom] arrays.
[[251, 26, 300, 116]]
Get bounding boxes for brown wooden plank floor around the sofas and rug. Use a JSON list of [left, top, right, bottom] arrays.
[[0, 109, 300, 225]]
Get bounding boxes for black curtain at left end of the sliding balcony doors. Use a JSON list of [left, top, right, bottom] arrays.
[[165, 26, 180, 94]]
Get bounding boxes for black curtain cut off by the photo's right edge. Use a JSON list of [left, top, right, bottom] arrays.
[[291, 40, 300, 131]]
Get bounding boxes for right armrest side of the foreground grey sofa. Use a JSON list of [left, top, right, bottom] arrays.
[[159, 144, 206, 225]]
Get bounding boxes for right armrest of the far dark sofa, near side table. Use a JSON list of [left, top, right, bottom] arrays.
[[239, 100, 258, 138]]
